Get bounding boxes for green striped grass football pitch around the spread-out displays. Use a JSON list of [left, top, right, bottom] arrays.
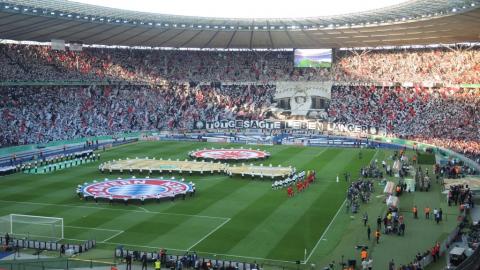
[[0, 142, 378, 264]]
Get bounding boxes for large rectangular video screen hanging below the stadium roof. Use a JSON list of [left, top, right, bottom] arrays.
[[294, 49, 332, 68]]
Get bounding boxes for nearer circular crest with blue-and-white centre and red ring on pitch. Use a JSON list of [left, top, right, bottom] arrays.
[[82, 178, 193, 199]]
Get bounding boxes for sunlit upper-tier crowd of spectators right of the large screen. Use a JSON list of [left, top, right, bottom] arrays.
[[336, 47, 480, 84]]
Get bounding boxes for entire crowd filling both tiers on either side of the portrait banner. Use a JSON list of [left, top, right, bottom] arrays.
[[0, 44, 480, 162]]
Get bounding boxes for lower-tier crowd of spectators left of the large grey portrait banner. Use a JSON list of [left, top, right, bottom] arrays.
[[0, 83, 274, 146]]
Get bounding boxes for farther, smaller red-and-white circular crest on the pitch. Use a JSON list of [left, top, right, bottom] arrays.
[[190, 149, 269, 160]]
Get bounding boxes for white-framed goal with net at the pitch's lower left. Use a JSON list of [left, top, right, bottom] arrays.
[[0, 214, 63, 241]]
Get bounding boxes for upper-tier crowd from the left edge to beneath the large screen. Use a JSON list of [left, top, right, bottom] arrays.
[[0, 44, 331, 84]]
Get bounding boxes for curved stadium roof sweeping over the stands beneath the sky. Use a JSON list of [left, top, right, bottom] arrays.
[[0, 0, 480, 48]]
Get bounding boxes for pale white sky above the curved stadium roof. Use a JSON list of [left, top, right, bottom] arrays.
[[70, 0, 406, 19]]
